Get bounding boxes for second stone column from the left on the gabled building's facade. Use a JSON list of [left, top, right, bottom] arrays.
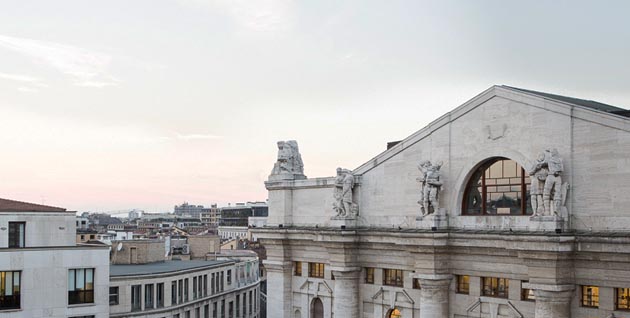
[[332, 268, 361, 318]]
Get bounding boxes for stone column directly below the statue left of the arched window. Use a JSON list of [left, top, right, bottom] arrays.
[[415, 274, 452, 318]]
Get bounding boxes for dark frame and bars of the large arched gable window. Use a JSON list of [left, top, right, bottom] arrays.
[[461, 157, 532, 216]]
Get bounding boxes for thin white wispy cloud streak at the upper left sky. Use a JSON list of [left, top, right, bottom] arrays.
[[0, 35, 118, 87]]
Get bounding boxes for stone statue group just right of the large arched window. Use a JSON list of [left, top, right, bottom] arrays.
[[529, 148, 569, 216]]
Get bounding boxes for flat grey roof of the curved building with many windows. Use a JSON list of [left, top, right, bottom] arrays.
[[109, 260, 234, 277]]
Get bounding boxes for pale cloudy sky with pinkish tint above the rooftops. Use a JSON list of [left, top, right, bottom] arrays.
[[0, 0, 630, 212]]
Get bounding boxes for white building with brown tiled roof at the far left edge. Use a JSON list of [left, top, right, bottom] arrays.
[[0, 199, 109, 318]]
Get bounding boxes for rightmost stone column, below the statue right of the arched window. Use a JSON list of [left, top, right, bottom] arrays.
[[531, 285, 574, 318]]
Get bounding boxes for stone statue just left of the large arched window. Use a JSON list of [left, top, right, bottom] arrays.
[[416, 160, 442, 215]]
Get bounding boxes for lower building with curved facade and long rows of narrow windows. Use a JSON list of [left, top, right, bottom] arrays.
[[109, 258, 260, 318]]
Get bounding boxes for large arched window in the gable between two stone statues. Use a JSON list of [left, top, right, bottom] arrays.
[[462, 158, 532, 215]]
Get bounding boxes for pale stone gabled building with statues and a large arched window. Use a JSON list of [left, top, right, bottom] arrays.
[[253, 86, 630, 318]]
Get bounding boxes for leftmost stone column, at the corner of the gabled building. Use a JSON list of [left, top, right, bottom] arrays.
[[264, 260, 293, 317]]
